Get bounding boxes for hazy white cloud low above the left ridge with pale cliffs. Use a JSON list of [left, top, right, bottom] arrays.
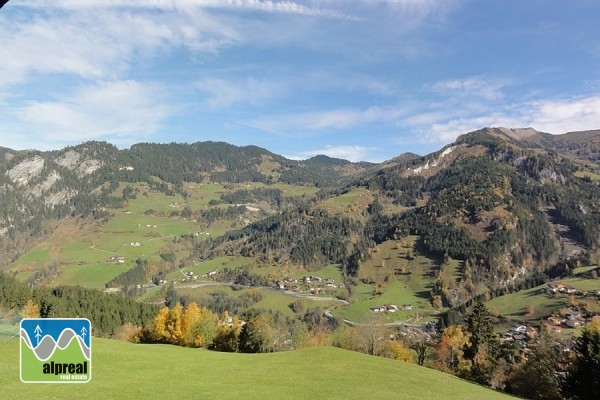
[[0, 81, 176, 148]]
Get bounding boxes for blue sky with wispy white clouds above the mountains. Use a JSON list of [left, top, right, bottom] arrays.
[[0, 0, 600, 162]]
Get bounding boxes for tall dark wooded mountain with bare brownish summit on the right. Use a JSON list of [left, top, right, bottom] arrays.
[[348, 128, 600, 306]]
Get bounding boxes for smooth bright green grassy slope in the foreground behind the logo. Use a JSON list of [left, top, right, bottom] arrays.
[[0, 339, 511, 400]]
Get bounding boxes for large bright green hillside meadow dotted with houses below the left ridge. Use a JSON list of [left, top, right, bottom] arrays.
[[7, 184, 234, 289]]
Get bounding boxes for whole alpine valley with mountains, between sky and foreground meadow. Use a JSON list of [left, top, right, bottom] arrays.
[[0, 128, 600, 394]]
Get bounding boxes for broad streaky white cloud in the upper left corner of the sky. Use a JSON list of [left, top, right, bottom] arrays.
[[0, 7, 242, 85]]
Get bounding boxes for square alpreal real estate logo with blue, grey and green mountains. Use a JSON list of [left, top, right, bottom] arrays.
[[21, 318, 92, 383]]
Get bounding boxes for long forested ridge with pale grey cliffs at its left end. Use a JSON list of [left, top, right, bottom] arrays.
[[0, 142, 371, 260]]
